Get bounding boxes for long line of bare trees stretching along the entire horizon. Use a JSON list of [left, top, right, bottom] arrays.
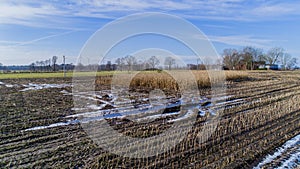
[[0, 46, 297, 72]]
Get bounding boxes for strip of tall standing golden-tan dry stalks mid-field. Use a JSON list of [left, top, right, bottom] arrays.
[[96, 70, 248, 92]]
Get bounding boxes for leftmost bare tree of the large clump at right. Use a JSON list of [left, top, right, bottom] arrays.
[[223, 49, 241, 70]]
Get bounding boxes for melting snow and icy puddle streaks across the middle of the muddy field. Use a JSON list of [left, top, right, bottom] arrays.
[[22, 92, 240, 131]]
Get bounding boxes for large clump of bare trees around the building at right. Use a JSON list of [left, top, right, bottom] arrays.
[[222, 46, 297, 70]]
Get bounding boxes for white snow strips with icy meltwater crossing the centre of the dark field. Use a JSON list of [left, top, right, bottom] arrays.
[[22, 92, 241, 131]]
